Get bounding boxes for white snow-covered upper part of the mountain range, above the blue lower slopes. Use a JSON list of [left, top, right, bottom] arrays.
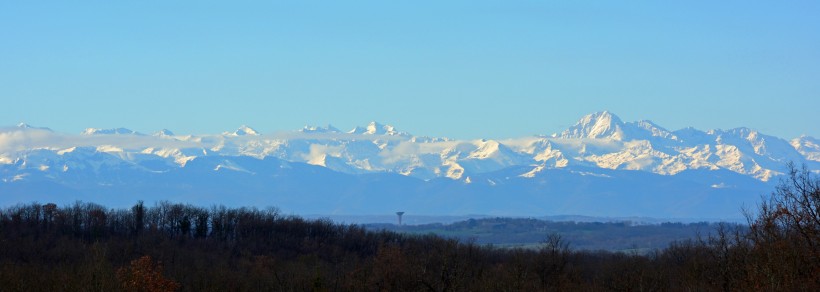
[[0, 111, 820, 181]]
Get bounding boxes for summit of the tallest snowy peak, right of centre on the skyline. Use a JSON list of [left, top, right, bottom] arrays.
[[561, 111, 624, 140]]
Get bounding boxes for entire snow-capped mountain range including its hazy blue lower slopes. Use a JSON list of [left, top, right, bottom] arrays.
[[0, 111, 820, 217]]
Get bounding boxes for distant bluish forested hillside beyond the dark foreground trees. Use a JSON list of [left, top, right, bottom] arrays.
[[363, 218, 728, 253]]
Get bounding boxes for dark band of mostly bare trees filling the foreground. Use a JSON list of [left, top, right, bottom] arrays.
[[0, 163, 820, 291]]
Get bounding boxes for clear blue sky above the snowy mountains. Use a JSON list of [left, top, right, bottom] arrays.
[[0, 0, 820, 138]]
